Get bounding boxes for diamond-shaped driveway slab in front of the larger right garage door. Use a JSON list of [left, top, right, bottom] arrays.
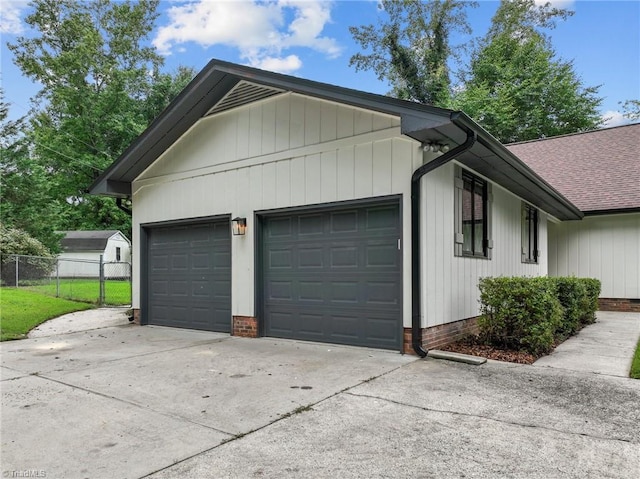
[[48, 337, 417, 434]]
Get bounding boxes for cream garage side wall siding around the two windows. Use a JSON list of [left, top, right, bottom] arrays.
[[421, 163, 547, 327]]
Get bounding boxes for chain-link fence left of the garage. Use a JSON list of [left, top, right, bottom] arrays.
[[0, 255, 131, 305]]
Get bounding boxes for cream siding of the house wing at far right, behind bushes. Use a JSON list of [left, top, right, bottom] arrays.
[[549, 213, 640, 299]]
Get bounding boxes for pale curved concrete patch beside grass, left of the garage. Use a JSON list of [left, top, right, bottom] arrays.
[[27, 307, 129, 338]]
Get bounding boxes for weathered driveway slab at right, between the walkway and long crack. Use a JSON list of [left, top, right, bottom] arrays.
[[350, 360, 640, 444]]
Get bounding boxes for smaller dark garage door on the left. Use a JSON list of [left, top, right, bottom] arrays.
[[147, 221, 231, 332]]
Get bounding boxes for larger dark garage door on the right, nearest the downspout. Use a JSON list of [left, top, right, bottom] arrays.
[[263, 202, 402, 349]]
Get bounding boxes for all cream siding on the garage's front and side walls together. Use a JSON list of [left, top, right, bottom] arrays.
[[133, 93, 547, 327]]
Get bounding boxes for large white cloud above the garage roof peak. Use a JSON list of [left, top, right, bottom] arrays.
[[153, 0, 341, 72]]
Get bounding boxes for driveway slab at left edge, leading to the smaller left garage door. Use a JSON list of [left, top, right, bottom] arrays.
[[0, 325, 229, 374]]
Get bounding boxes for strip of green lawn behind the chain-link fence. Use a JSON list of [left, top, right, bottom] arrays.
[[28, 279, 131, 306]]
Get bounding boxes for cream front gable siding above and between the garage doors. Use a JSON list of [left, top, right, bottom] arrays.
[[133, 93, 422, 324]]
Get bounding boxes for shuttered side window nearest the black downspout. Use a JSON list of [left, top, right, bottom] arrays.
[[454, 166, 493, 258]]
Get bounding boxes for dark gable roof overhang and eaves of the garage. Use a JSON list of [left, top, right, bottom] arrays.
[[89, 60, 582, 219]]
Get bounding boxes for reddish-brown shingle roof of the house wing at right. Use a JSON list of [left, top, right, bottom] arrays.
[[507, 123, 640, 214]]
